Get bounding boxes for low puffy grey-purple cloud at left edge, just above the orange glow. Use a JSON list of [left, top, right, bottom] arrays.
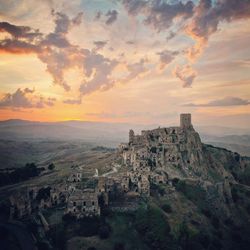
[[0, 88, 56, 109]]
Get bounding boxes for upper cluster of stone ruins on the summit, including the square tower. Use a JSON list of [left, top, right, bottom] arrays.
[[120, 114, 204, 182]]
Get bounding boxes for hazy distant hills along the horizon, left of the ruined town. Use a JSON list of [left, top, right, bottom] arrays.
[[0, 120, 153, 147]]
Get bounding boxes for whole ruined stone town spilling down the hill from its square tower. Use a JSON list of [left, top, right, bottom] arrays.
[[6, 114, 202, 218]]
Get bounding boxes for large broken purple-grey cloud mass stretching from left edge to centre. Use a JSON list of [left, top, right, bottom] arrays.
[[0, 11, 148, 95]]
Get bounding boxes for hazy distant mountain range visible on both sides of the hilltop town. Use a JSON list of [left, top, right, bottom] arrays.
[[0, 119, 250, 156]]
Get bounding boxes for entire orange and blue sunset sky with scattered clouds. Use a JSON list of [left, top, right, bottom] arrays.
[[0, 0, 250, 127]]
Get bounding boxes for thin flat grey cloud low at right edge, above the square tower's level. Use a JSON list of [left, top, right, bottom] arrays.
[[183, 97, 250, 107]]
